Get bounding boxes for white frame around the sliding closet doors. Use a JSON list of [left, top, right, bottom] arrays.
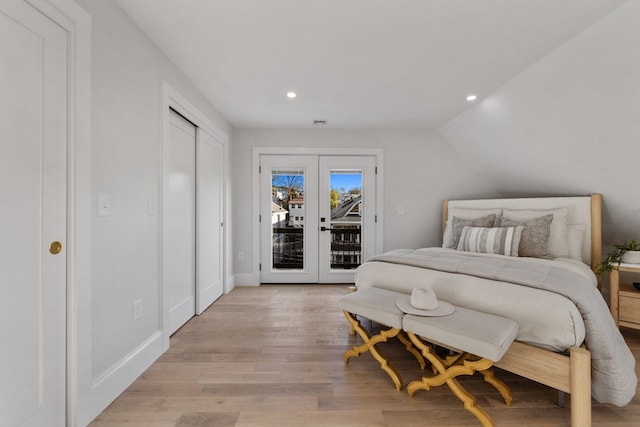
[[159, 81, 229, 352]]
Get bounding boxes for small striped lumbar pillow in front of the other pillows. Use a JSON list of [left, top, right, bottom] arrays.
[[458, 225, 524, 256]]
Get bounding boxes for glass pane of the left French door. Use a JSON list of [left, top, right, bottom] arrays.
[[271, 168, 305, 270]]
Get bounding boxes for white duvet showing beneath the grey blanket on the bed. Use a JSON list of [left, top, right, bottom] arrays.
[[356, 248, 596, 352]]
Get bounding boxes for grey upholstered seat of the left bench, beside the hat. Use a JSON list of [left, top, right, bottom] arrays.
[[339, 288, 404, 329]]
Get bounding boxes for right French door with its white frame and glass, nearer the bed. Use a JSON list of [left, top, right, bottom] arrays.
[[319, 156, 376, 283]]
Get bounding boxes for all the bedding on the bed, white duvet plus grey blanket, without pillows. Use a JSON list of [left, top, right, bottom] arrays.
[[355, 248, 637, 406]]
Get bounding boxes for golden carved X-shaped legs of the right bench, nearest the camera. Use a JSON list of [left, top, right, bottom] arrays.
[[407, 332, 511, 427]]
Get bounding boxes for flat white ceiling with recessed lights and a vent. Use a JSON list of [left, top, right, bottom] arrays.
[[117, 0, 622, 129]]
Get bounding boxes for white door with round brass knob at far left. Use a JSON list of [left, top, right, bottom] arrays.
[[0, 0, 68, 427]]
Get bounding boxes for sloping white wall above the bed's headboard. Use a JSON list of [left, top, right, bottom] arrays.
[[440, 0, 640, 243]]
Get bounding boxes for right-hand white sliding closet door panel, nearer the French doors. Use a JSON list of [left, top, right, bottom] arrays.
[[196, 128, 224, 314]]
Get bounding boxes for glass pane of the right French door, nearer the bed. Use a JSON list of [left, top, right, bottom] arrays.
[[329, 169, 363, 270]]
